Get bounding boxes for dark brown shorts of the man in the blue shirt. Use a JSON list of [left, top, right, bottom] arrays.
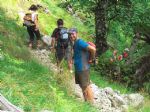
[[75, 70, 90, 88]]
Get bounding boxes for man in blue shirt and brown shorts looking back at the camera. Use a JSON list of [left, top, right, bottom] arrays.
[[69, 28, 96, 103]]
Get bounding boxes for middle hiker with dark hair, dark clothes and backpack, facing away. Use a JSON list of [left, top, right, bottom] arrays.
[[51, 19, 73, 73]]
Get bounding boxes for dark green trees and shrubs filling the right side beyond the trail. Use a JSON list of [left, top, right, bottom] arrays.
[[66, 0, 150, 92]]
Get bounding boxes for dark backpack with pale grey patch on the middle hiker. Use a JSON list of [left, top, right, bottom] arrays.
[[58, 27, 69, 49]]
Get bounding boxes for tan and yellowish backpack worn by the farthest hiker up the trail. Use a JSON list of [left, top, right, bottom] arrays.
[[23, 13, 35, 27]]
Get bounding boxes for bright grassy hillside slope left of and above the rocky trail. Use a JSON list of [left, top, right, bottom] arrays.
[[0, 0, 96, 112]]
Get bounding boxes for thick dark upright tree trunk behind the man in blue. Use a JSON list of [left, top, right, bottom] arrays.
[[95, 0, 108, 55]]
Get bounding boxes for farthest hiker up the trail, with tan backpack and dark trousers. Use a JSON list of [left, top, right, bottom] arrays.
[[23, 4, 41, 48]]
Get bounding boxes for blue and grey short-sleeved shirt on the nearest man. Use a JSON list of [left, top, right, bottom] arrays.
[[74, 39, 90, 71]]
